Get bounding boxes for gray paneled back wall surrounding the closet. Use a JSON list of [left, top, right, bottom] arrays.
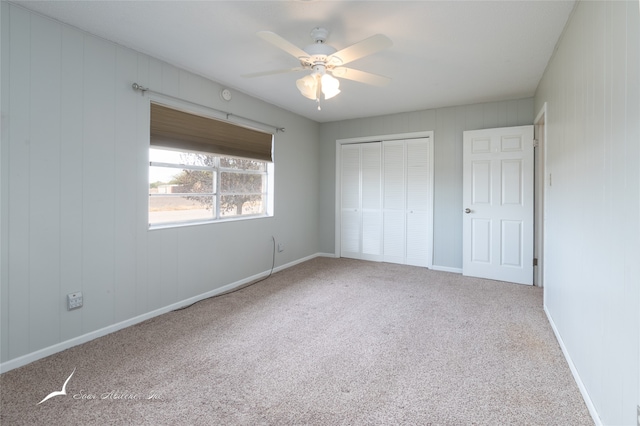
[[320, 98, 535, 271]]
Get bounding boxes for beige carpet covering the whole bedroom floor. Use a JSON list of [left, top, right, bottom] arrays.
[[0, 258, 592, 426]]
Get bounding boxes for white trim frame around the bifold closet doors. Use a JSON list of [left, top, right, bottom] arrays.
[[334, 130, 435, 268]]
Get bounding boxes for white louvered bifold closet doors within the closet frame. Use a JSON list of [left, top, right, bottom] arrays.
[[340, 138, 432, 266]]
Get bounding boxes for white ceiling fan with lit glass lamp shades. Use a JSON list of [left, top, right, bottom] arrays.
[[243, 27, 393, 109]]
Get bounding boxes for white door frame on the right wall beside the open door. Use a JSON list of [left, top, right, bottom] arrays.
[[533, 102, 551, 287]]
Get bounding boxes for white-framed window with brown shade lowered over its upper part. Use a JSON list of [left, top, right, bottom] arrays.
[[149, 104, 273, 228]]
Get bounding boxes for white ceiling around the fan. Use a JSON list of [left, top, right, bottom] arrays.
[[13, 0, 574, 122]]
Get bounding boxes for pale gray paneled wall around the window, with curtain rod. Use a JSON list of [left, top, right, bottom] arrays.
[[0, 2, 319, 363]]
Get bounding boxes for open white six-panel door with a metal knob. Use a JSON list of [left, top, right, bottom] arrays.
[[462, 126, 534, 285]]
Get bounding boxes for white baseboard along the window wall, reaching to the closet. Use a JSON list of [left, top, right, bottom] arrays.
[[0, 253, 328, 373]]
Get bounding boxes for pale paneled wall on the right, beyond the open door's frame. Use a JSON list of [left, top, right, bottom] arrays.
[[535, 0, 640, 425]]
